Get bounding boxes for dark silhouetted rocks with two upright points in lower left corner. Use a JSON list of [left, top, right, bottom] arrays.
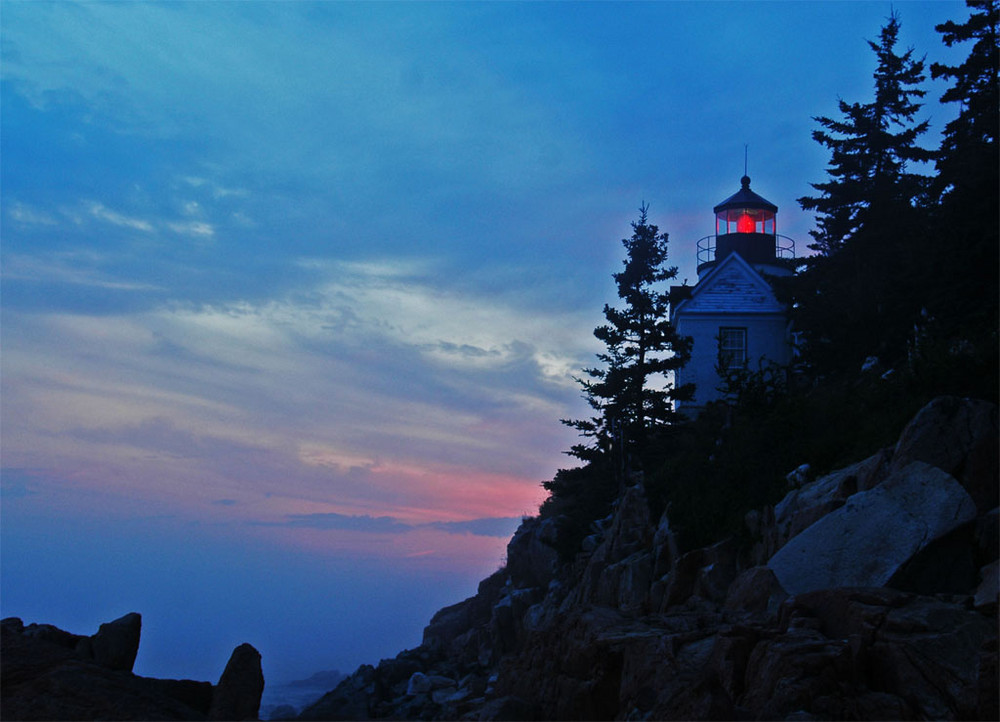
[[0, 613, 264, 720]]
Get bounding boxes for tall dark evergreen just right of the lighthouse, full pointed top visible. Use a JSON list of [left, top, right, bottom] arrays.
[[785, 13, 933, 372]]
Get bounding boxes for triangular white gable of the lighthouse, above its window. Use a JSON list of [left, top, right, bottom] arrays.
[[671, 252, 785, 318]]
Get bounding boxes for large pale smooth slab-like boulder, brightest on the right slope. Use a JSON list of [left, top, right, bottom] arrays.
[[768, 461, 975, 594]]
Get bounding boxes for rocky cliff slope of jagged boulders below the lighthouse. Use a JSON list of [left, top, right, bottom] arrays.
[[300, 397, 998, 720]]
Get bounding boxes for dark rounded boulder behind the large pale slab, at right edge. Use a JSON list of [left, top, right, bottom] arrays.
[[891, 396, 1000, 514]]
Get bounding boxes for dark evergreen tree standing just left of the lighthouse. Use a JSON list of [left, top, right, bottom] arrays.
[[563, 204, 693, 464]]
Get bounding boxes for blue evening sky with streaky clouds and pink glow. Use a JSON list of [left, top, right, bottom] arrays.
[[0, 0, 967, 681]]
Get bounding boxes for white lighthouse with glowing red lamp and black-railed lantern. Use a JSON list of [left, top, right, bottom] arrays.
[[670, 175, 795, 415]]
